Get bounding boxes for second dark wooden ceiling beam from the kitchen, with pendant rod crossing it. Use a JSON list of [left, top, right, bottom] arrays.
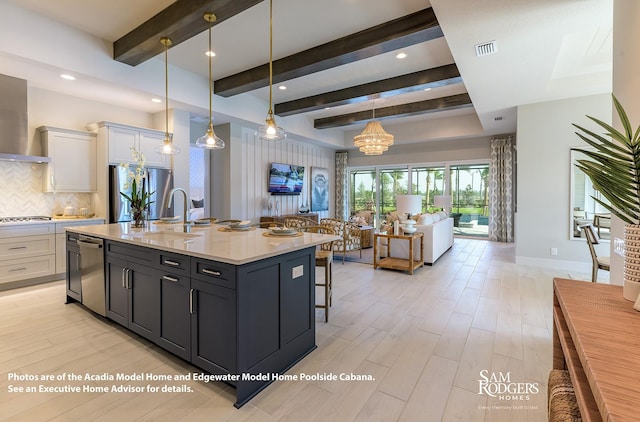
[[214, 8, 443, 97]]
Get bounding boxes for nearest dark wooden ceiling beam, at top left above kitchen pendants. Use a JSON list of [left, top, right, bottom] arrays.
[[113, 0, 263, 66]]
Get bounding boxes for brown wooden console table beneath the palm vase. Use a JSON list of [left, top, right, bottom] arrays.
[[553, 278, 640, 421]]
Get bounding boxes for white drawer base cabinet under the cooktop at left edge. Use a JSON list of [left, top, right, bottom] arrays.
[[0, 223, 55, 283]]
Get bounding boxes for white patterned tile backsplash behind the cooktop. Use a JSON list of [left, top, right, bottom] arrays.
[[0, 161, 93, 217]]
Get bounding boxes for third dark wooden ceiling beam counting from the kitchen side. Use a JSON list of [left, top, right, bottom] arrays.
[[275, 64, 462, 116]]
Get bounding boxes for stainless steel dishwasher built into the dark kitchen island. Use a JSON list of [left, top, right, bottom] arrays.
[[77, 234, 107, 316]]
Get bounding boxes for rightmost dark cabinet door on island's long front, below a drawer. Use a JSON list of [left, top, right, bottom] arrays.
[[191, 279, 237, 374]]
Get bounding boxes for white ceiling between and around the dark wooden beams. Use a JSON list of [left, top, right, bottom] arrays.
[[5, 0, 613, 147]]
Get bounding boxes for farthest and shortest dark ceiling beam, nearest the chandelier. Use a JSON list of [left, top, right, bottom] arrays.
[[313, 93, 472, 129]]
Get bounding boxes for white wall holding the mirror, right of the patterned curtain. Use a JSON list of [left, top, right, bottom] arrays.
[[515, 94, 611, 269]]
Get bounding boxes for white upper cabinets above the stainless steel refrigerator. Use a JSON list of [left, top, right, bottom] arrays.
[[98, 122, 171, 168]]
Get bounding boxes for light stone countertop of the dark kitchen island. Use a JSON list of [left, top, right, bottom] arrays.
[[67, 223, 339, 265]]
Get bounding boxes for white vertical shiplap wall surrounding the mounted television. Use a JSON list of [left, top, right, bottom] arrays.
[[236, 128, 335, 222]]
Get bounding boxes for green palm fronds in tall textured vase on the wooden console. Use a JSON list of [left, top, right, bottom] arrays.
[[573, 96, 640, 301]]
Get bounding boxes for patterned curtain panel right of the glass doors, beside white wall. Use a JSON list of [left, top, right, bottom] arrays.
[[489, 136, 515, 242]]
